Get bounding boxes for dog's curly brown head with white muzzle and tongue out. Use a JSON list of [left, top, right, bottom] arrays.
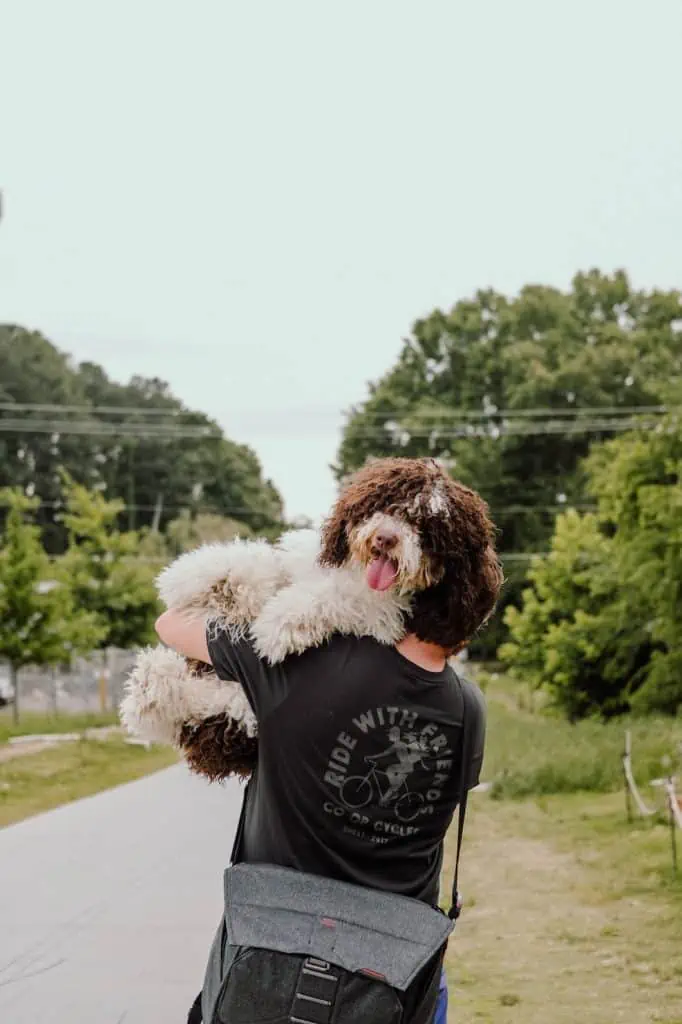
[[319, 459, 502, 650]]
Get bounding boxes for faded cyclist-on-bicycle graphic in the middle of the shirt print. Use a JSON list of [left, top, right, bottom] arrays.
[[341, 726, 430, 822]]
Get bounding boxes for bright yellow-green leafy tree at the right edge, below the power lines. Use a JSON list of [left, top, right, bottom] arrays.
[[501, 418, 682, 718]]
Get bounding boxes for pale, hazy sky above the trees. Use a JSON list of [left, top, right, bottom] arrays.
[[0, 0, 682, 519]]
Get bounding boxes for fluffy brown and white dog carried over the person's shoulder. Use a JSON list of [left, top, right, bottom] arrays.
[[121, 459, 502, 779]]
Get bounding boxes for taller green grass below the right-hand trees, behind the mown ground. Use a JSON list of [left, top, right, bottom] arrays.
[[473, 675, 682, 800]]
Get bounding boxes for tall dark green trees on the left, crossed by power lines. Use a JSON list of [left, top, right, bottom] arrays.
[[0, 325, 283, 553]]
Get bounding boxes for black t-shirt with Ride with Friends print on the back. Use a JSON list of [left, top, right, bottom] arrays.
[[209, 634, 485, 904]]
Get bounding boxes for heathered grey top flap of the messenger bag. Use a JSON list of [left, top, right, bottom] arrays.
[[225, 863, 453, 991]]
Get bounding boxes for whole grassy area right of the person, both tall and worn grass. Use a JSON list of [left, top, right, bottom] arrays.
[[443, 679, 682, 1024]]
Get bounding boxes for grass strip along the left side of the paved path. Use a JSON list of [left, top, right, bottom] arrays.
[[0, 736, 177, 827]]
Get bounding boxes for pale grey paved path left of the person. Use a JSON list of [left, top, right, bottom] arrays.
[[0, 767, 241, 1024]]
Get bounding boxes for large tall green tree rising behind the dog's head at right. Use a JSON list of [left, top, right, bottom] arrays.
[[334, 270, 682, 655]]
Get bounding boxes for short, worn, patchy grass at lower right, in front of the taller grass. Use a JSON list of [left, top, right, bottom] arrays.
[[444, 794, 682, 1024]]
